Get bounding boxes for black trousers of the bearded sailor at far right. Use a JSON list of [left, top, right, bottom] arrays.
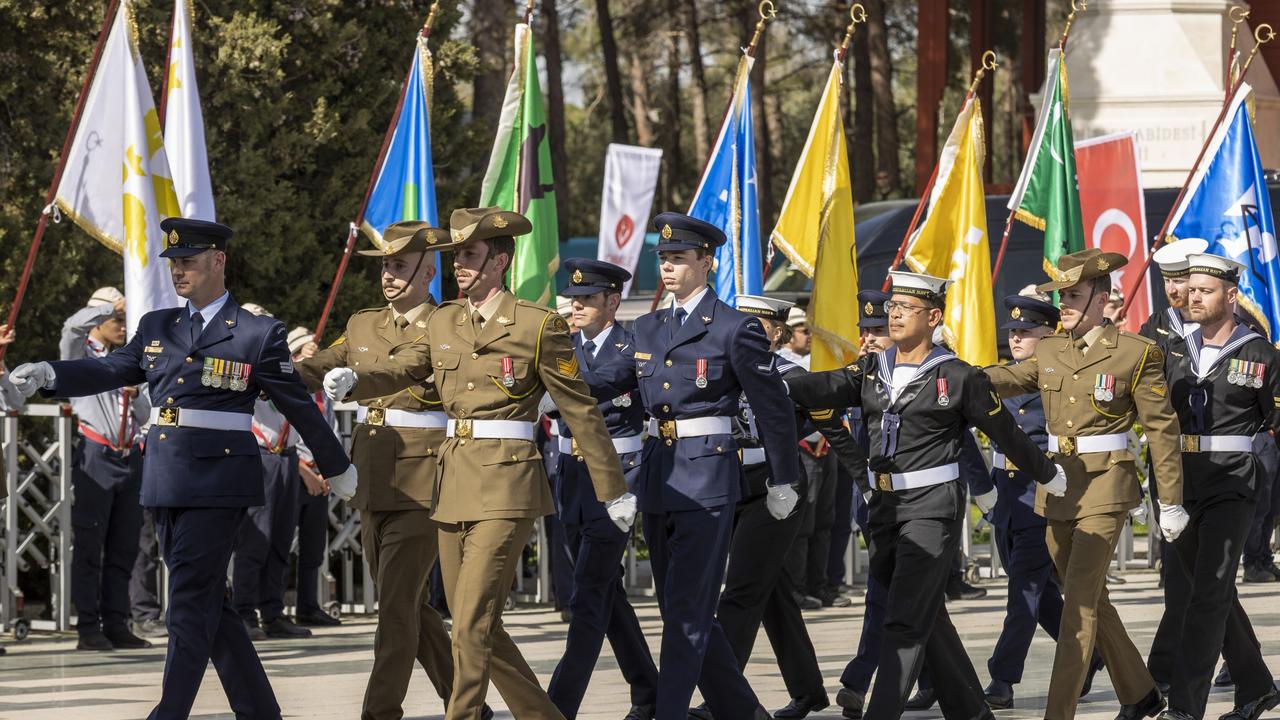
[[1169, 495, 1272, 717]]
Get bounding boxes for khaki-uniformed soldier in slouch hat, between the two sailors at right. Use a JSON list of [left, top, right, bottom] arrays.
[[987, 249, 1187, 720]]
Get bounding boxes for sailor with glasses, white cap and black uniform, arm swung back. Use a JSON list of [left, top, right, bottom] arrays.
[[788, 272, 1065, 719]]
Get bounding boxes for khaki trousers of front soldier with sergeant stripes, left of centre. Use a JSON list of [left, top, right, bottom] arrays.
[[439, 518, 564, 720]]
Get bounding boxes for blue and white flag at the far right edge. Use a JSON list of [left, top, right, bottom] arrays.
[[1169, 83, 1280, 342]]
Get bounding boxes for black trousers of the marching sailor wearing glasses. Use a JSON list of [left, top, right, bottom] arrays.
[[864, 509, 991, 720]]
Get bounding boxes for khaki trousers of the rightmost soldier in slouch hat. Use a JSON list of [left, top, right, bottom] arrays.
[[1044, 510, 1156, 720]]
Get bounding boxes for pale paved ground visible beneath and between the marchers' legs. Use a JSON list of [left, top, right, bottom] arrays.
[[0, 573, 1280, 720]]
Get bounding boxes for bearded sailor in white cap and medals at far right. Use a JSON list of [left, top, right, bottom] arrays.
[[1161, 252, 1280, 720]]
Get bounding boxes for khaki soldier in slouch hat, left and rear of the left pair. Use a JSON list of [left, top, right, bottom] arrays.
[[297, 220, 481, 720]]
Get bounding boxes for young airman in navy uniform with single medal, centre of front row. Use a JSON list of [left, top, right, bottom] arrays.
[[635, 213, 800, 720]]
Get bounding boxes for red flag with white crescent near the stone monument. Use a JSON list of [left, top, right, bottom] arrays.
[[1075, 132, 1152, 333]]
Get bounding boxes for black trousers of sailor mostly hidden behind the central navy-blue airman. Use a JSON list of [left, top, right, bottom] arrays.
[[716, 495, 824, 698]]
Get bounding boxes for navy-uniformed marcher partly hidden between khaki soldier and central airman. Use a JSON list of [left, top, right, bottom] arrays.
[[547, 259, 658, 720]]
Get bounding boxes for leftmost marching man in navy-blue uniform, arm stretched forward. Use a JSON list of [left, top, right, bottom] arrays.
[[12, 218, 356, 719]]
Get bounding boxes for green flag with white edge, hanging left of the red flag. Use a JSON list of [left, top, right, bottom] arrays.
[[1009, 47, 1084, 278]]
